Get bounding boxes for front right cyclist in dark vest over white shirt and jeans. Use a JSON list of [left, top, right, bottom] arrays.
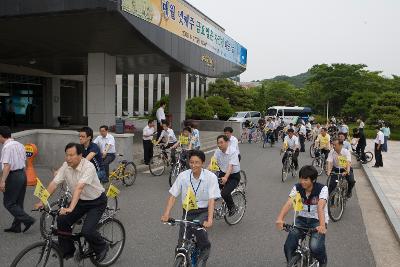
[[276, 166, 329, 267]]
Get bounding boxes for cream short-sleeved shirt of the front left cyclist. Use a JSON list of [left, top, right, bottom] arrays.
[[53, 158, 104, 200]]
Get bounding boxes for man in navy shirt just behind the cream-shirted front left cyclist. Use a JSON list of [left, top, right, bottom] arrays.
[[79, 126, 108, 183]]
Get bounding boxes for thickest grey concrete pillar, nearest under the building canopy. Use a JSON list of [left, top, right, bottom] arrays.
[[87, 53, 116, 130]]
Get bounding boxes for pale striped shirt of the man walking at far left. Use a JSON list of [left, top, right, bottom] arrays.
[[0, 138, 26, 171]]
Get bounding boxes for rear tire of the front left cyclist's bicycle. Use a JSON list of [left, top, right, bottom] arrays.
[[90, 218, 126, 267]]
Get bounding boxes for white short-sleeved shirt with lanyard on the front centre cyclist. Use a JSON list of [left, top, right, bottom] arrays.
[[169, 169, 221, 208]]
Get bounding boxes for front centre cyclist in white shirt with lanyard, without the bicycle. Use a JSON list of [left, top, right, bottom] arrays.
[[161, 150, 221, 267]]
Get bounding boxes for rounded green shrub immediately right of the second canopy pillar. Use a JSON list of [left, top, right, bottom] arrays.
[[186, 97, 214, 120]]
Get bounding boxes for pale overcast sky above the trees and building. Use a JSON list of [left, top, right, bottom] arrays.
[[187, 0, 400, 81]]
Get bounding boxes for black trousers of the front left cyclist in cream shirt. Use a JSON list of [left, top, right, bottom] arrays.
[[57, 193, 107, 255]]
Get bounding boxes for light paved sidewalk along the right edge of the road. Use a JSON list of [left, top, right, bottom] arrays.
[[362, 140, 400, 242]]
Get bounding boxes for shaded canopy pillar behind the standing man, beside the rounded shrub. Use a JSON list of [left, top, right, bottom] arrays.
[[169, 72, 187, 132]]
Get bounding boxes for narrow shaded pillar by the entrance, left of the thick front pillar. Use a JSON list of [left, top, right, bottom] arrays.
[[46, 77, 61, 127]]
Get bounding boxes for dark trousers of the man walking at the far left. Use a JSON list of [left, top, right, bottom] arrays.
[[3, 169, 34, 229]]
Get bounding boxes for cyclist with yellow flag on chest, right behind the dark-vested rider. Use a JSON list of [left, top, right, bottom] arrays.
[[327, 139, 356, 198]]
